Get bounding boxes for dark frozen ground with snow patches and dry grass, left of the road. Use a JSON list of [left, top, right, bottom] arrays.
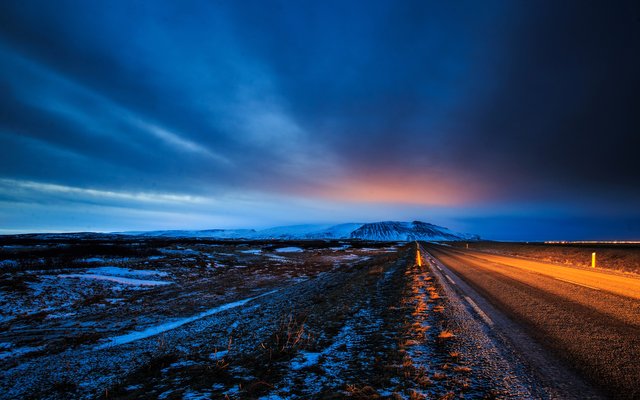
[[0, 237, 544, 399]]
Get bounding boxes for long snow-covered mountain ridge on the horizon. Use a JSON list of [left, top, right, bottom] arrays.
[[119, 221, 479, 241]]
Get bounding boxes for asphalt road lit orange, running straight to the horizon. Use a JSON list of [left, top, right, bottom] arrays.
[[423, 244, 640, 399]]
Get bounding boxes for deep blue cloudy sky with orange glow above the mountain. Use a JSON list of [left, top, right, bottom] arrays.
[[0, 0, 640, 240]]
